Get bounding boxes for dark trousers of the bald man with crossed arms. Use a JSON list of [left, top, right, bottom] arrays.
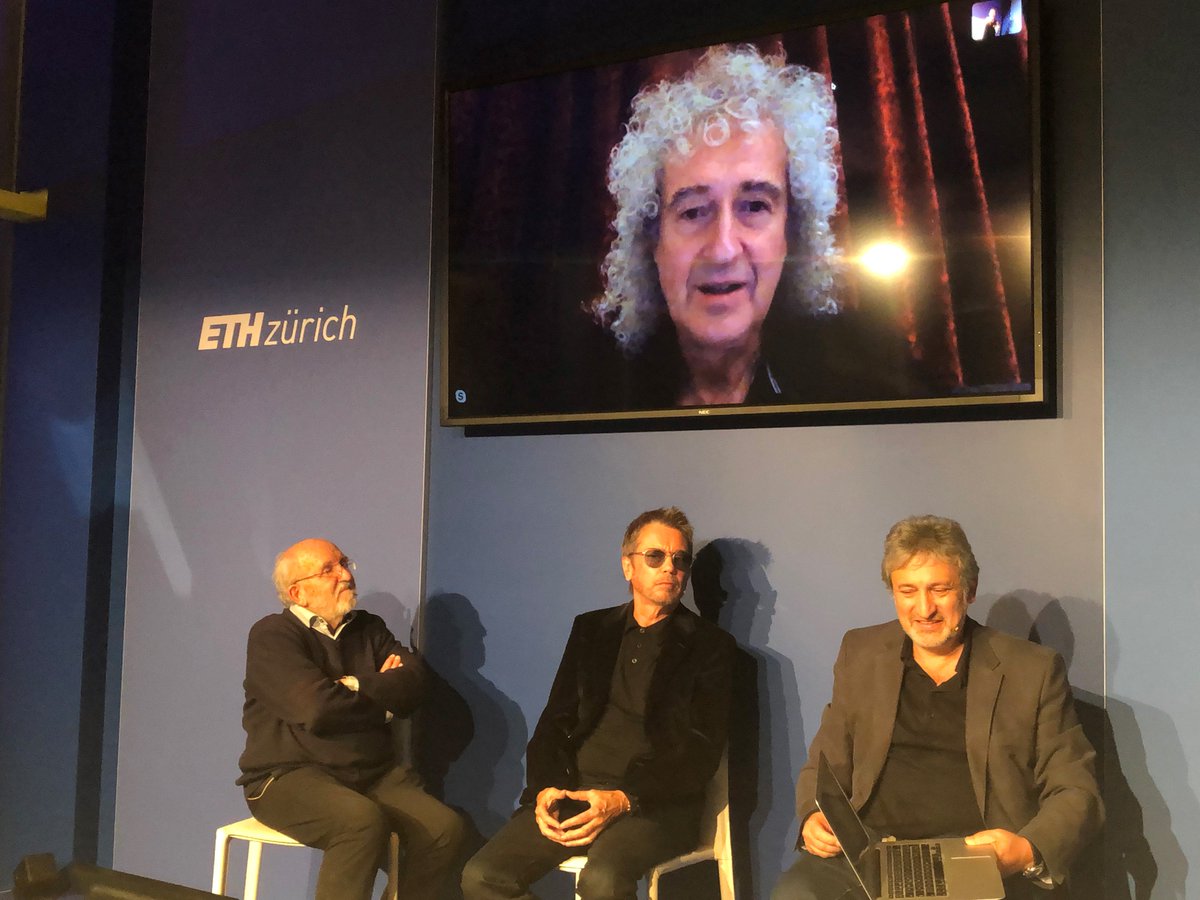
[[246, 767, 463, 900]]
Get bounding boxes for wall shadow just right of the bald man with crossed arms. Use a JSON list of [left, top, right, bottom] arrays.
[[413, 594, 529, 852]]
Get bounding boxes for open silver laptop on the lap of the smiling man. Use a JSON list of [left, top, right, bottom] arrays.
[[816, 754, 1004, 900]]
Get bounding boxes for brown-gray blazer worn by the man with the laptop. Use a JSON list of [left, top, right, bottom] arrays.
[[796, 622, 1104, 882]]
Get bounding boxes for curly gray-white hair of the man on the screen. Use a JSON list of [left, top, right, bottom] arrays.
[[592, 44, 838, 352]]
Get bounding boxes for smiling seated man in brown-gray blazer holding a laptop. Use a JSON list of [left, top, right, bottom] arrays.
[[773, 516, 1103, 900]]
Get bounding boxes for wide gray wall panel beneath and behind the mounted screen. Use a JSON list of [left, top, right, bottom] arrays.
[[426, 11, 1104, 896]]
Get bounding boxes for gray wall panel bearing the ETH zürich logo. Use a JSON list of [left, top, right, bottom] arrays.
[[115, 4, 433, 896]]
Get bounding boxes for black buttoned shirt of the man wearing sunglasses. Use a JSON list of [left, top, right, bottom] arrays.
[[576, 604, 670, 788]]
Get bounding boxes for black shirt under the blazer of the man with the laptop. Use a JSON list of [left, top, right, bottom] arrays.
[[862, 619, 983, 840]]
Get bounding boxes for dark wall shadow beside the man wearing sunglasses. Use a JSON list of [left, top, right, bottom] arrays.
[[691, 538, 808, 896]]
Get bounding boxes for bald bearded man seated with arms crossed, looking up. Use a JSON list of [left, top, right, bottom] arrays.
[[238, 539, 463, 900]]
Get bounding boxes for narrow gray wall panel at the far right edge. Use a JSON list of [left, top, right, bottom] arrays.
[[1104, 2, 1200, 899]]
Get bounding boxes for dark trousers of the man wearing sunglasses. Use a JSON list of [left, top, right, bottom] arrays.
[[462, 804, 700, 900]]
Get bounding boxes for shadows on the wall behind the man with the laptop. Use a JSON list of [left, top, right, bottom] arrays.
[[988, 590, 1195, 900]]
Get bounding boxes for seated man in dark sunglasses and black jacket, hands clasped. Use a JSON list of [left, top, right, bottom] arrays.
[[462, 508, 734, 900]]
